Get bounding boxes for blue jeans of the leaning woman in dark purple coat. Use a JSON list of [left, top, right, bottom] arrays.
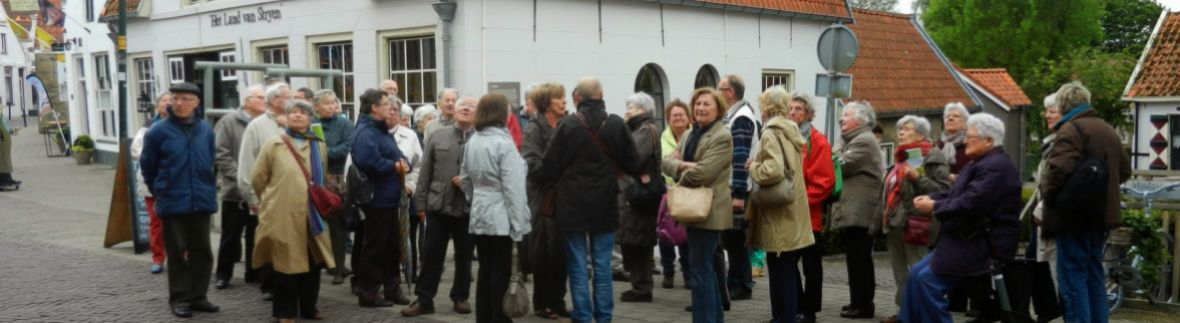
[[897, 253, 965, 323]]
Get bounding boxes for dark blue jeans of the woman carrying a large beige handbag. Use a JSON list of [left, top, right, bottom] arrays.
[[688, 228, 722, 323]]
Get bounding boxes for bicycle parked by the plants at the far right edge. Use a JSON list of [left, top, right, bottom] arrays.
[[1102, 182, 1180, 314]]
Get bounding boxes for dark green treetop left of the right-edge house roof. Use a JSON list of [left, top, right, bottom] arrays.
[[1102, 0, 1163, 54]]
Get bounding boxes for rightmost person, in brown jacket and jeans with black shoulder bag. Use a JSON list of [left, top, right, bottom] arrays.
[[1040, 81, 1130, 322]]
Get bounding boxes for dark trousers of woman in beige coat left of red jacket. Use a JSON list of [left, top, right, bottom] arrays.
[[766, 251, 799, 323]]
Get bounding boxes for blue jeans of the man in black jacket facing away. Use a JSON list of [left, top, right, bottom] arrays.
[[565, 232, 615, 323]]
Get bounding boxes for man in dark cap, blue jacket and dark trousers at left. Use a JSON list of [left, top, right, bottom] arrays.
[[139, 83, 218, 317]]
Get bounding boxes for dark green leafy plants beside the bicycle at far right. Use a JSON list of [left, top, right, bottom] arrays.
[[1122, 209, 1172, 286]]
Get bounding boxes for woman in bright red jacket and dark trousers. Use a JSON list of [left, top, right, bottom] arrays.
[[787, 92, 835, 323]]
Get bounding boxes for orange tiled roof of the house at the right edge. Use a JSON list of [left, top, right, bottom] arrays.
[[1127, 12, 1180, 97]]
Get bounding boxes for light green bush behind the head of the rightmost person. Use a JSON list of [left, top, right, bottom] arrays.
[[1021, 47, 1138, 140]]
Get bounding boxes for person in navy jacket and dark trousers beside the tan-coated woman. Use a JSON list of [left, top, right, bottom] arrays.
[[352, 88, 409, 308]]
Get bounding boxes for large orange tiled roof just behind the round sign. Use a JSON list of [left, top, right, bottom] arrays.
[[848, 9, 972, 113]]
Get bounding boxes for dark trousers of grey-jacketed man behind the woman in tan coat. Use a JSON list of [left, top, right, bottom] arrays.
[[217, 200, 258, 282]]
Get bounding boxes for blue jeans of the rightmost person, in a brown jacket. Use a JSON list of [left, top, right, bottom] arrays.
[[1057, 232, 1110, 323]]
